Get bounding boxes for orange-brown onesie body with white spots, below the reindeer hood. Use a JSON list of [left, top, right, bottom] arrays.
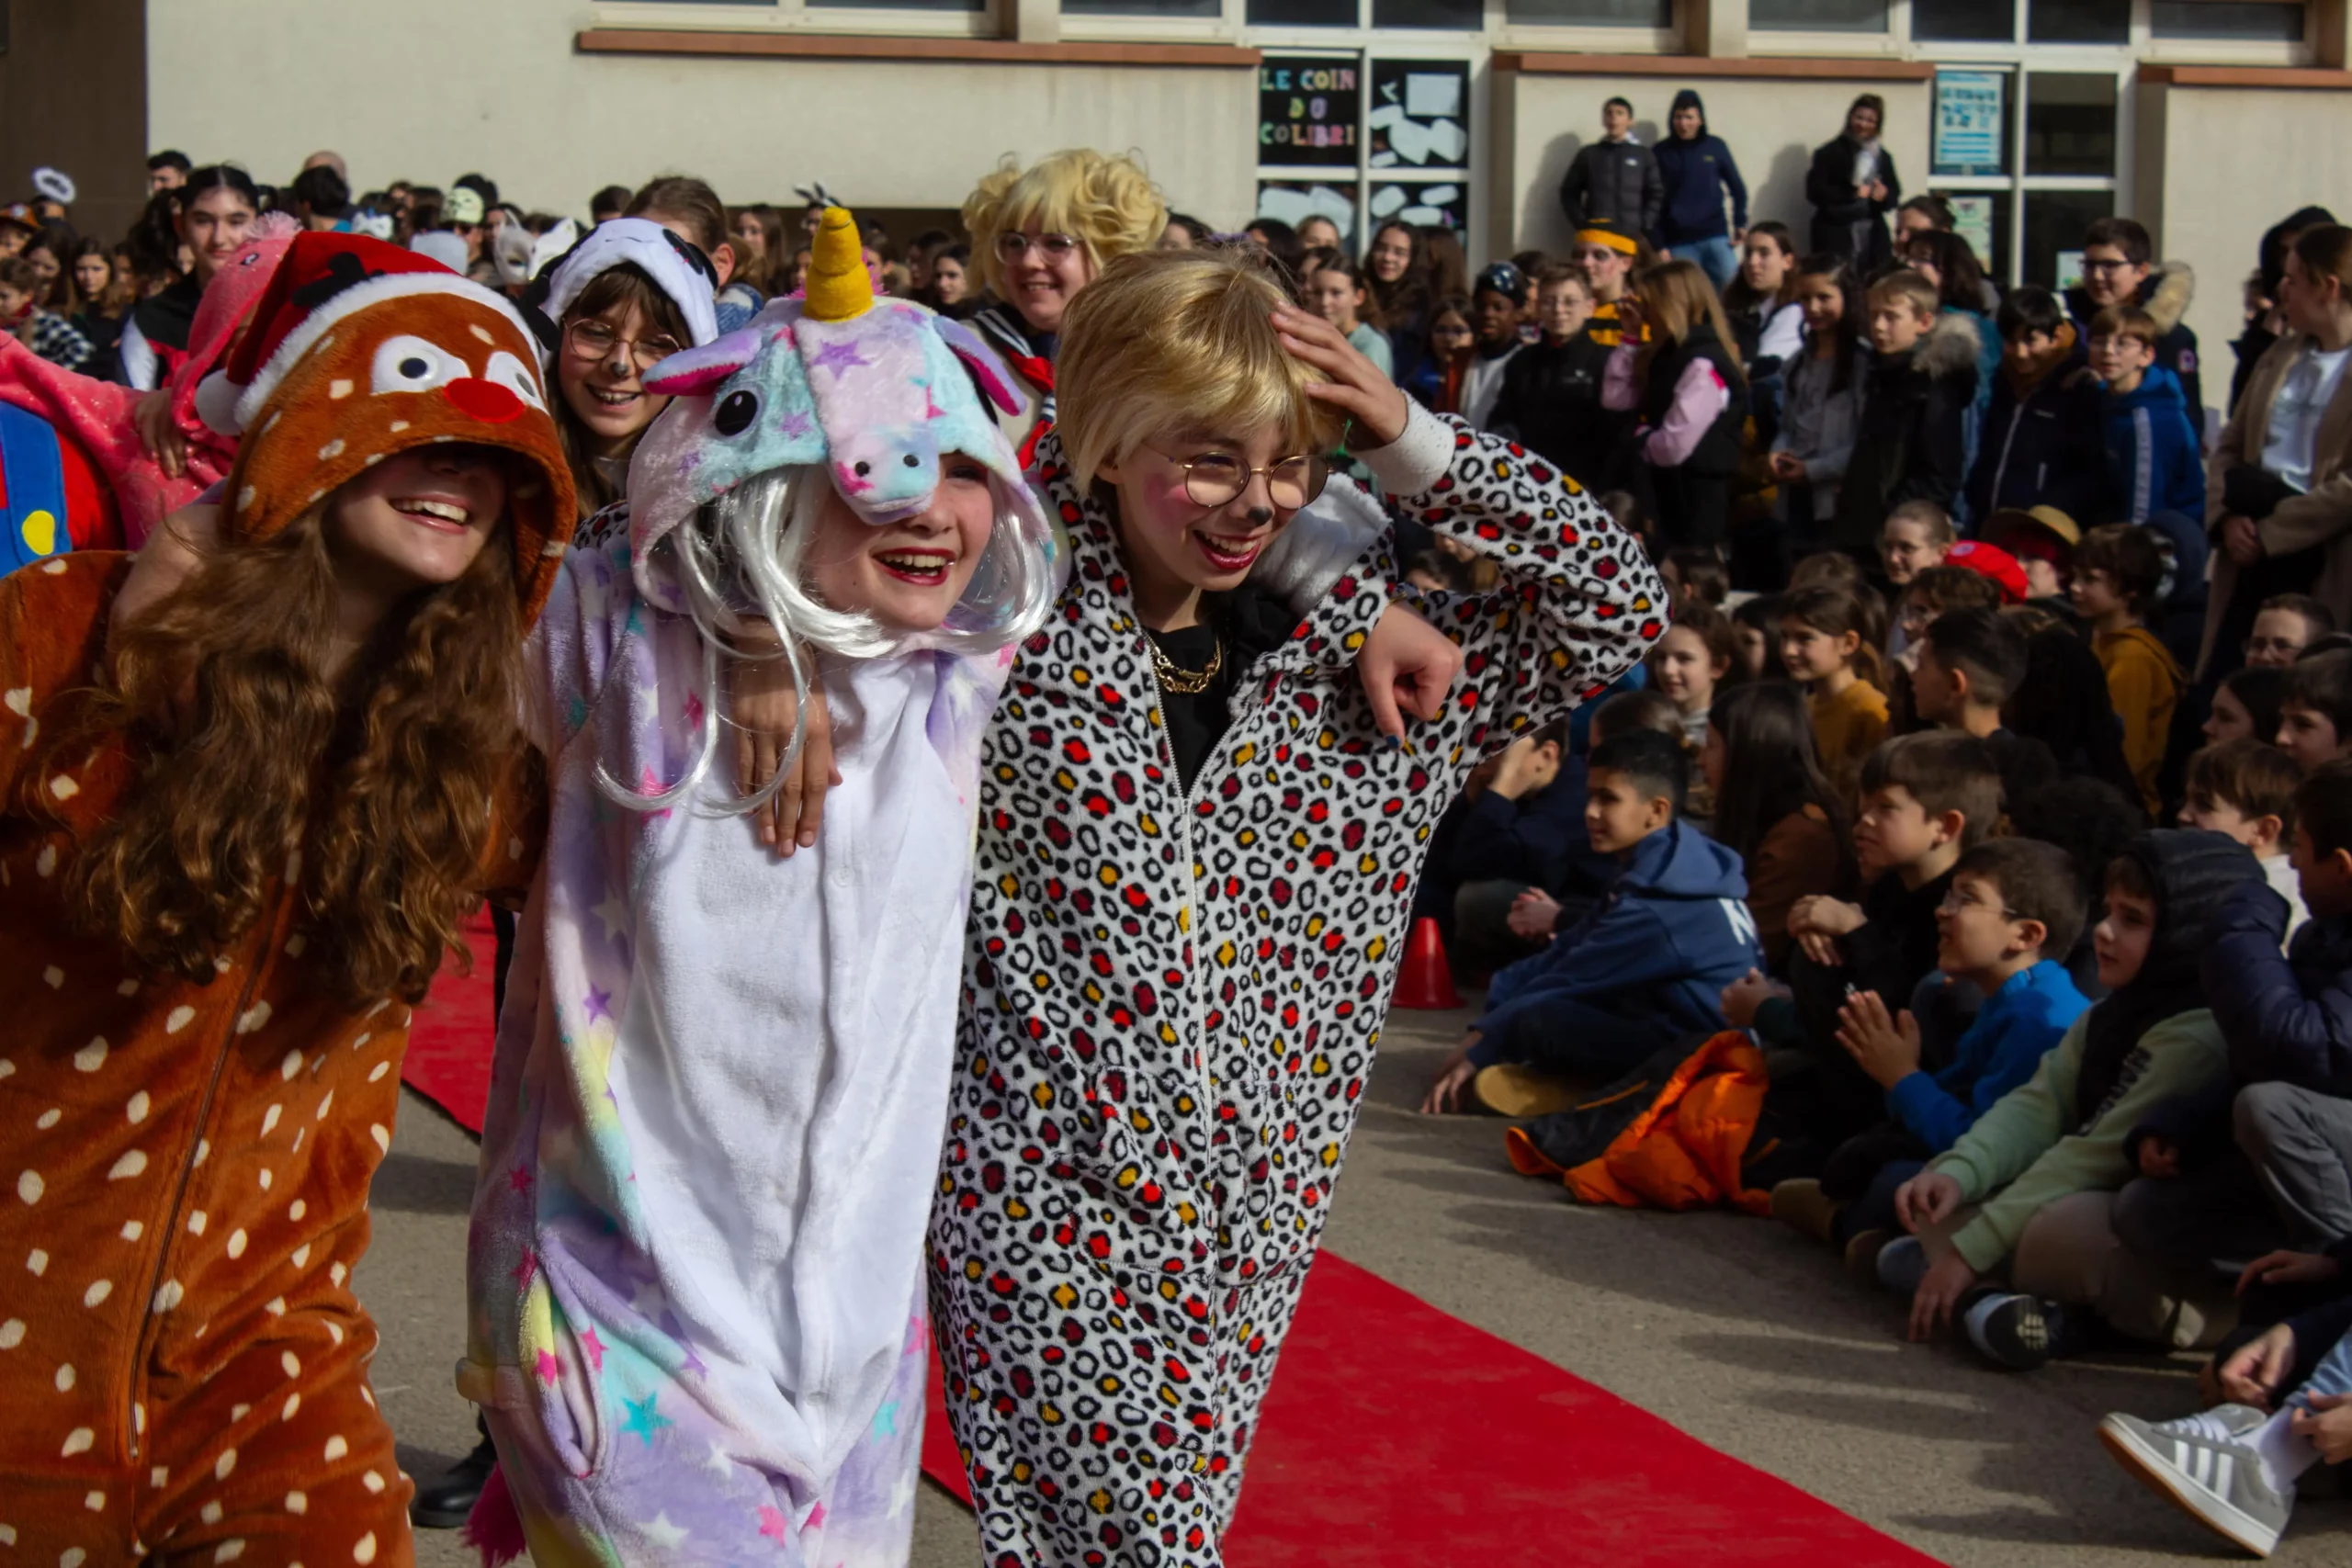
[[0, 552, 526, 1568]]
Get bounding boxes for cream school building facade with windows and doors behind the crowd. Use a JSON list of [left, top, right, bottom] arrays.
[[0, 0, 2352, 389]]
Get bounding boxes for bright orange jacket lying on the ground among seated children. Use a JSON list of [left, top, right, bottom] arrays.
[[1503, 1030, 1771, 1215]]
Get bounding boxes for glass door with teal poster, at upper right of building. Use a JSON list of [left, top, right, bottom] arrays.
[[1912, 0, 2145, 289]]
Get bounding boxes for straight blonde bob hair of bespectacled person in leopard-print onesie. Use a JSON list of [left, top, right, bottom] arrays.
[[1054, 247, 1339, 487]]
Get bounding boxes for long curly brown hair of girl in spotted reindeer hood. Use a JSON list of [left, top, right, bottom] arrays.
[[42, 501, 522, 1006]]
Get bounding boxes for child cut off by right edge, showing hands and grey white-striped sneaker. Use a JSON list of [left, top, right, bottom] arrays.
[[2098, 1295, 2352, 1556]]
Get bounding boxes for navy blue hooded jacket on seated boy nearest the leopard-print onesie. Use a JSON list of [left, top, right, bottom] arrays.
[[1470, 818, 1764, 1067]]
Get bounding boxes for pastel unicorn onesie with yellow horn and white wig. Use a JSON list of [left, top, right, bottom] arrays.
[[458, 209, 1054, 1568]]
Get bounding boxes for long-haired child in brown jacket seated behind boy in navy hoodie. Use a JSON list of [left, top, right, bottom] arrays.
[[1698, 682, 1853, 974]]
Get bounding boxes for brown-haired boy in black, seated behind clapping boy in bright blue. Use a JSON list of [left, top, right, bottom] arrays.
[[1722, 731, 2002, 1155]]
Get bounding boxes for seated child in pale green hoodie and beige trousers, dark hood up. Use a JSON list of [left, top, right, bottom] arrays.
[[1879, 829, 2263, 1371]]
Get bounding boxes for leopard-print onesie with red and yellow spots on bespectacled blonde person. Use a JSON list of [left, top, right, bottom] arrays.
[[932, 416, 1665, 1568]]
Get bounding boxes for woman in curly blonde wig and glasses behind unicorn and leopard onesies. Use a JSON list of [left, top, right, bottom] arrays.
[[965, 148, 1169, 463]]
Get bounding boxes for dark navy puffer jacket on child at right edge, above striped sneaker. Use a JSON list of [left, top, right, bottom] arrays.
[[2204, 877, 2352, 1098]]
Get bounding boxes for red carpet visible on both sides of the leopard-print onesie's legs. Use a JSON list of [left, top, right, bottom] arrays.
[[922, 1253, 1936, 1568]]
